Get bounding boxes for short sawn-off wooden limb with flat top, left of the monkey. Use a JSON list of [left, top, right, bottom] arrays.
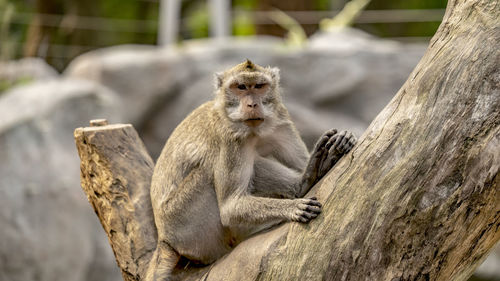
[[75, 120, 156, 281]]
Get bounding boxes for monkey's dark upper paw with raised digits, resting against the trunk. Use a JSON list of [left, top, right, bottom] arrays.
[[302, 129, 356, 191]]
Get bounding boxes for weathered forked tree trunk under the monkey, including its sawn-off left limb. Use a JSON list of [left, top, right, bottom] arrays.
[[75, 0, 500, 281]]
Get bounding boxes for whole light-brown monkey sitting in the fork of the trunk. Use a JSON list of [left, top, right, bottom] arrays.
[[145, 60, 356, 281]]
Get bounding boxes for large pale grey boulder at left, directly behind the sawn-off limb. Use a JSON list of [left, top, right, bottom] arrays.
[[0, 79, 121, 281]]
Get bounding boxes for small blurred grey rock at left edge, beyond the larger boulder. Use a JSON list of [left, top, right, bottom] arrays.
[[0, 58, 59, 93]]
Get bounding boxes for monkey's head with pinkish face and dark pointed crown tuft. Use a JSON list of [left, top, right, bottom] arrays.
[[215, 59, 282, 136]]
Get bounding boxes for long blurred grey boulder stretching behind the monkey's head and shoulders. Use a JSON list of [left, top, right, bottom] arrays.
[[65, 29, 425, 157]]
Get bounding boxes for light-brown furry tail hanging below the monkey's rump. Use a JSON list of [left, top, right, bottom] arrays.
[[144, 241, 180, 281]]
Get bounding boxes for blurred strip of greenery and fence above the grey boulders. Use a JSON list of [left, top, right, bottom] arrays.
[[0, 0, 446, 71]]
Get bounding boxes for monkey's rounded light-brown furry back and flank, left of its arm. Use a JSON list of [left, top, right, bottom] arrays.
[[151, 102, 229, 263]]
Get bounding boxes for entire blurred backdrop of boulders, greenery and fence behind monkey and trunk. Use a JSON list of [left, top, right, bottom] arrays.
[[0, 0, 500, 281]]
